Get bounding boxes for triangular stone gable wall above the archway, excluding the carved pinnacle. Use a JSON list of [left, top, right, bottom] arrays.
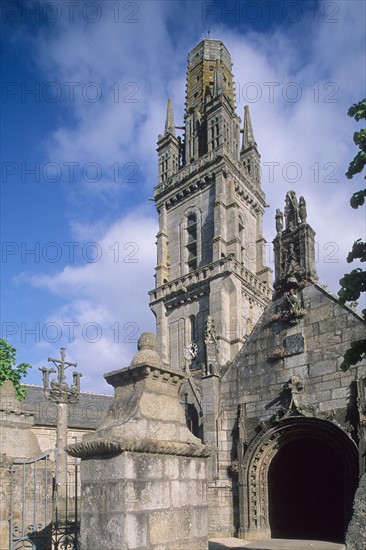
[[222, 283, 366, 429]]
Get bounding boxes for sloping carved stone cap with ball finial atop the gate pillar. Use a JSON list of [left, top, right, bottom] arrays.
[[67, 333, 211, 458]]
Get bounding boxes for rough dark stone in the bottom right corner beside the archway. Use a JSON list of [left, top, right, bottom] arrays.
[[346, 474, 366, 550]]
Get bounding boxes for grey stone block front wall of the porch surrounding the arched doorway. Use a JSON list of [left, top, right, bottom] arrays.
[[209, 284, 366, 536]]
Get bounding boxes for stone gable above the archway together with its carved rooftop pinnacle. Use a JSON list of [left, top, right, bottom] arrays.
[[222, 191, 366, 431]]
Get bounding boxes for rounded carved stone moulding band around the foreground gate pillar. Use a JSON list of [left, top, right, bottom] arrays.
[[65, 437, 216, 458]]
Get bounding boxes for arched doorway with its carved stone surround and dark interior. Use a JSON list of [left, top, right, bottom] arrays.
[[239, 415, 359, 541]]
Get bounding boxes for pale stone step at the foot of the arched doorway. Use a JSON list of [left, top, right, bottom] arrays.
[[208, 538, 345, 550]]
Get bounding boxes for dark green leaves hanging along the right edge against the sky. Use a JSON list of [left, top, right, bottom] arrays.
[[338, 98, 366, 371]]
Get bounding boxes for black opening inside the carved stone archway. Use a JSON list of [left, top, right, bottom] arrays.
[[268, 437, 346, 542]]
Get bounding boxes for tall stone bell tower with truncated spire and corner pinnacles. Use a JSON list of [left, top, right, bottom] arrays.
[[150, 38, 272, 374]]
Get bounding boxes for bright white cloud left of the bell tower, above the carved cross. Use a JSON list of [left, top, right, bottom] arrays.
[[19, 209, 157, 391]]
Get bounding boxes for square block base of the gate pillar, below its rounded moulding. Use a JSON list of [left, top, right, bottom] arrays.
[[81, 452, 207, 550]]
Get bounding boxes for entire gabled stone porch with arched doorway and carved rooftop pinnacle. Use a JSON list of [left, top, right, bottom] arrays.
[[216, 192, 366, 541]]
